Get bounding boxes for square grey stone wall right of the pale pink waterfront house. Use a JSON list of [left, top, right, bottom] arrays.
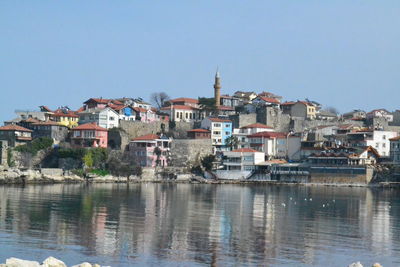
[[171, 139, 213, 168]]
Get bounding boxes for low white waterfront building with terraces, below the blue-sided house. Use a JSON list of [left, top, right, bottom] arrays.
[[223, 148, 264, 171]]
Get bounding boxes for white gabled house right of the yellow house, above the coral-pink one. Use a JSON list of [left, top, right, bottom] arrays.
[[78, 107, 119, 129]]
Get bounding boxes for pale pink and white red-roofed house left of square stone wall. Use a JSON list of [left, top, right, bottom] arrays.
[[129, 134, 171, 167]]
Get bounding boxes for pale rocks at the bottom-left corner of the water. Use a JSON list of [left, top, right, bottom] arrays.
[[0, 257, 105, 267]]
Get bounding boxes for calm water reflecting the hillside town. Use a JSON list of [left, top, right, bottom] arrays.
[[0, 184, 400, 267]]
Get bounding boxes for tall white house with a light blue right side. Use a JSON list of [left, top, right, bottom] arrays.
[[201, 117, 232, 151]]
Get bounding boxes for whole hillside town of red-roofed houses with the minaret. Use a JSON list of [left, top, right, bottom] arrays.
[[0, 72, 400, 184]]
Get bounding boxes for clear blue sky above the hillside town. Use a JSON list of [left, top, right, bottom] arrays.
[[0, 0, 400, 121]]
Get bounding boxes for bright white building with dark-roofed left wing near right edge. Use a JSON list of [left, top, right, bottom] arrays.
[[347, 130, 398, 157]]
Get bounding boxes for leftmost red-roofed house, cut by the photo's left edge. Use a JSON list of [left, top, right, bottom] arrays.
[[0, 124, 32, 147]]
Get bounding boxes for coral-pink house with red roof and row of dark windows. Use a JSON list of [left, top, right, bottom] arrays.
[[71, 122, 108, 148]]
